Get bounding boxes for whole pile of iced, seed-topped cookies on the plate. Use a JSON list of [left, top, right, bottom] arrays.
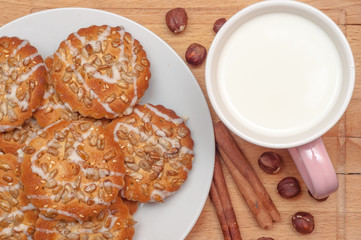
[[0, 25, 193, 240]]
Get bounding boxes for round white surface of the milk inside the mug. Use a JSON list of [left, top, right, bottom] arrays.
[[217, 13, 342, 136]]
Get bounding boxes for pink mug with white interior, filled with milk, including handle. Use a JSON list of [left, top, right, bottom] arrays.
[[205, 0, 355, 198]]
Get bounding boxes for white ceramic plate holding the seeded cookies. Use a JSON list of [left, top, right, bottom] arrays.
[[0, 8, 214, 240]]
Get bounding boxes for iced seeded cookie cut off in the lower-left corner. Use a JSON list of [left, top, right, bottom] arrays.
[[0, 154, 39, 240]]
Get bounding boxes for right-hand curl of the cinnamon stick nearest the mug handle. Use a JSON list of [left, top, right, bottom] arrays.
[[214, 122, 280, 222]]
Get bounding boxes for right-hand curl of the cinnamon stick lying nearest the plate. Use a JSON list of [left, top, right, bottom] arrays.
[[213, 154, 242, 240]]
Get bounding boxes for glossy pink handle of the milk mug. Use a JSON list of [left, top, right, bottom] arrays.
[[288, 137, 338, 199]]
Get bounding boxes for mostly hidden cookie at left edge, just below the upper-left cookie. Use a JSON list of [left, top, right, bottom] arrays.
[[0, 118, 41, 155]]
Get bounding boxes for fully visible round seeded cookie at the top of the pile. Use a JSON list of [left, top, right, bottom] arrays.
[[50, 25, 150, 119]]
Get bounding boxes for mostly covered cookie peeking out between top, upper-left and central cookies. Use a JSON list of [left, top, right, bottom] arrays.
[[34, 56, 84, 127]]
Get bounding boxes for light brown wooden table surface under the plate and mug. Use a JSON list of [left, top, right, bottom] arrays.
[[0, 0, 361, 240]]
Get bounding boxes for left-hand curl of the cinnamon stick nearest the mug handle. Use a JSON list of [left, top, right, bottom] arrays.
[[220, 148, 272, 229]]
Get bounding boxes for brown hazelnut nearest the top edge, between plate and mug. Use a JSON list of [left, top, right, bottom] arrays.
[[165, 8, 188, 33]]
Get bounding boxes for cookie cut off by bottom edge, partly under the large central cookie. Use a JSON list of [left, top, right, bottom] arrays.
[[34, 197, 135, 240]]
